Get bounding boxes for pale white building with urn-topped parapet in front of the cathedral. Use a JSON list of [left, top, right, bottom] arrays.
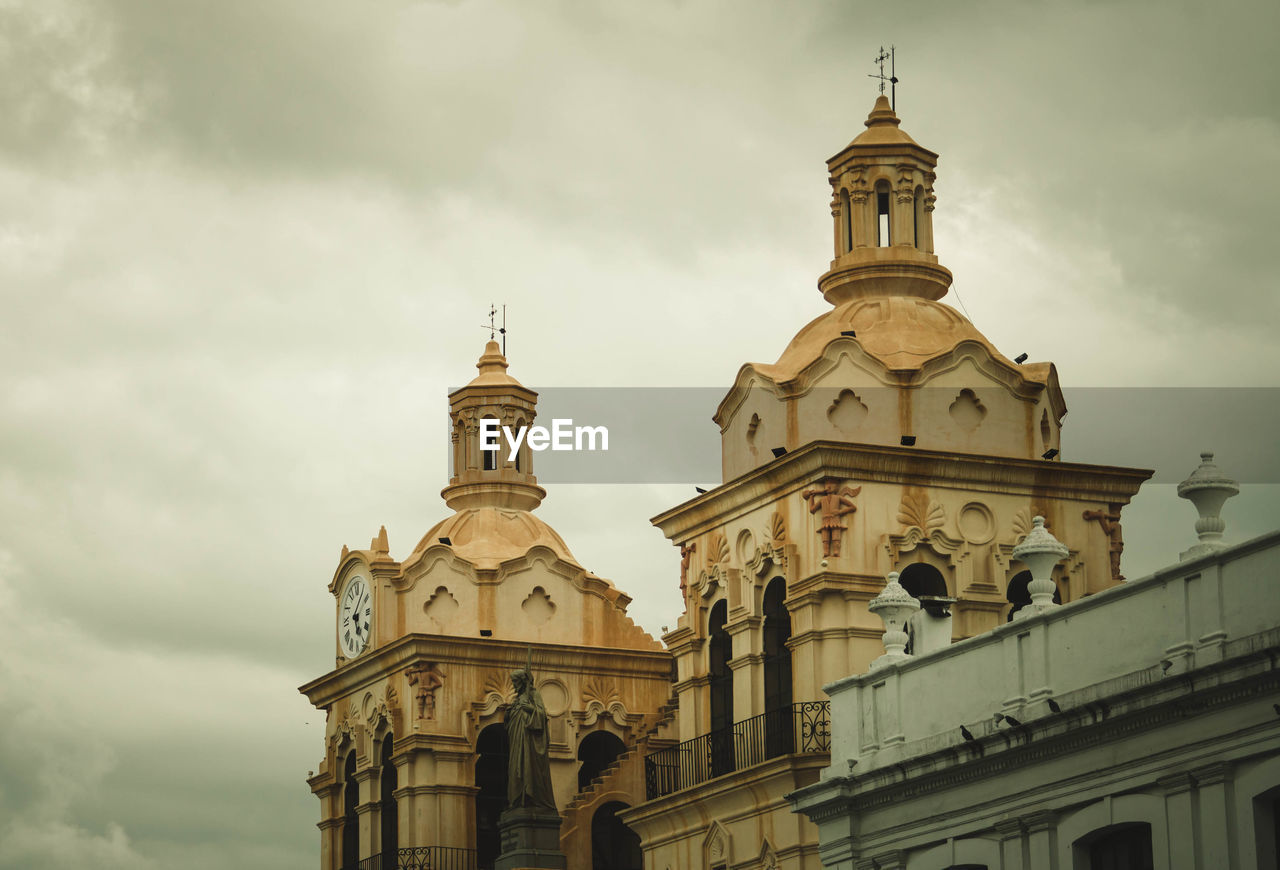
[[788, 503, 1280, 870]]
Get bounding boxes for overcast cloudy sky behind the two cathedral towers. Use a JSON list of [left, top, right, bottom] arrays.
[[0, 0, 1280, 870]]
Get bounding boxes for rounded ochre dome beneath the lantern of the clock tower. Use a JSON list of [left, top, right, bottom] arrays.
[[413, 507, 581, 568]]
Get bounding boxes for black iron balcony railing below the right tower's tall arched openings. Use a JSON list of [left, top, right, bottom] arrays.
[[644, 701, 831, 801]]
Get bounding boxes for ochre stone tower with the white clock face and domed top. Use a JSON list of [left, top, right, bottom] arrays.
[[301, 342, 671, 870]]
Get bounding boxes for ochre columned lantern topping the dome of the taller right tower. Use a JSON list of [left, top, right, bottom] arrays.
[[818, 93, 951, 305]]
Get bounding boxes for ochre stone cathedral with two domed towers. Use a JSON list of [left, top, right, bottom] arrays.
[[301, 96, 1280, 870]]
